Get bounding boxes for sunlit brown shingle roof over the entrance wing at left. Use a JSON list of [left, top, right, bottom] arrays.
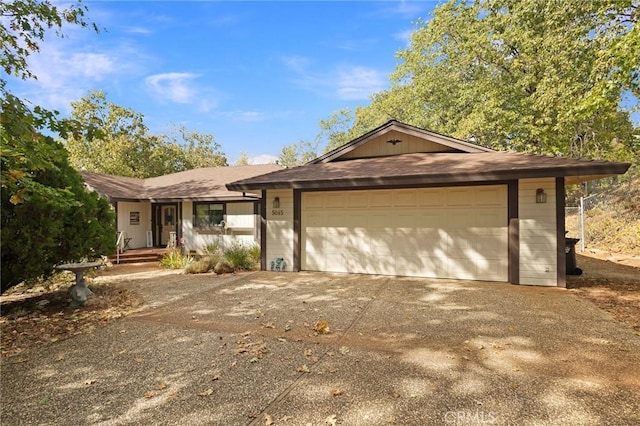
[[80, 164, 282, 201]]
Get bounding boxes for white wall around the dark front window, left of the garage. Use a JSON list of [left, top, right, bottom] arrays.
[[182, 201, 259, 254]]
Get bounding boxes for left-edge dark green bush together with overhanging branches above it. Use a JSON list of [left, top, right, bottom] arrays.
[[0, 0, 115, 292]]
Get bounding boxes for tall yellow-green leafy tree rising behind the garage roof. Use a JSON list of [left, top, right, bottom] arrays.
[[326, 0, 640, 162]]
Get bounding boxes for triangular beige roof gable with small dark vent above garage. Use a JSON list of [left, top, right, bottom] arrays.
[[309, 120, 494, 164]]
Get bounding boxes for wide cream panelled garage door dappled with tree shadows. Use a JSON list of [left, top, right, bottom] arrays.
[[301, 185, 508, 281]]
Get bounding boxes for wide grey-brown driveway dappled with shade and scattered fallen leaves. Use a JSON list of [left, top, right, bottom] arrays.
[[0, 272, 640, 425]]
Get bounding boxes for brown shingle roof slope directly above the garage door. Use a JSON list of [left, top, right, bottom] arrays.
[[227, 152, 630, 191]]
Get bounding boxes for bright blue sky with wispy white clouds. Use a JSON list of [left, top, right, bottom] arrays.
[[8, 1, 437, 164]]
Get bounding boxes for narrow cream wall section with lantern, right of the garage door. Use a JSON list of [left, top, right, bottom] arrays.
[[518, 178, 558, 286]]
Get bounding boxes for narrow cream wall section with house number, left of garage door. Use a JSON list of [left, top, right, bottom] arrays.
[[263, 189, 293, 271]]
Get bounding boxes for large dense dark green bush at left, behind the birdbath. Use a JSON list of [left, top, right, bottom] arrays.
[[0, 94, 115, 292]]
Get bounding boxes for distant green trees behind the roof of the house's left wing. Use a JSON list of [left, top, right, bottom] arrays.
[[66, 91, 227, 178]]
